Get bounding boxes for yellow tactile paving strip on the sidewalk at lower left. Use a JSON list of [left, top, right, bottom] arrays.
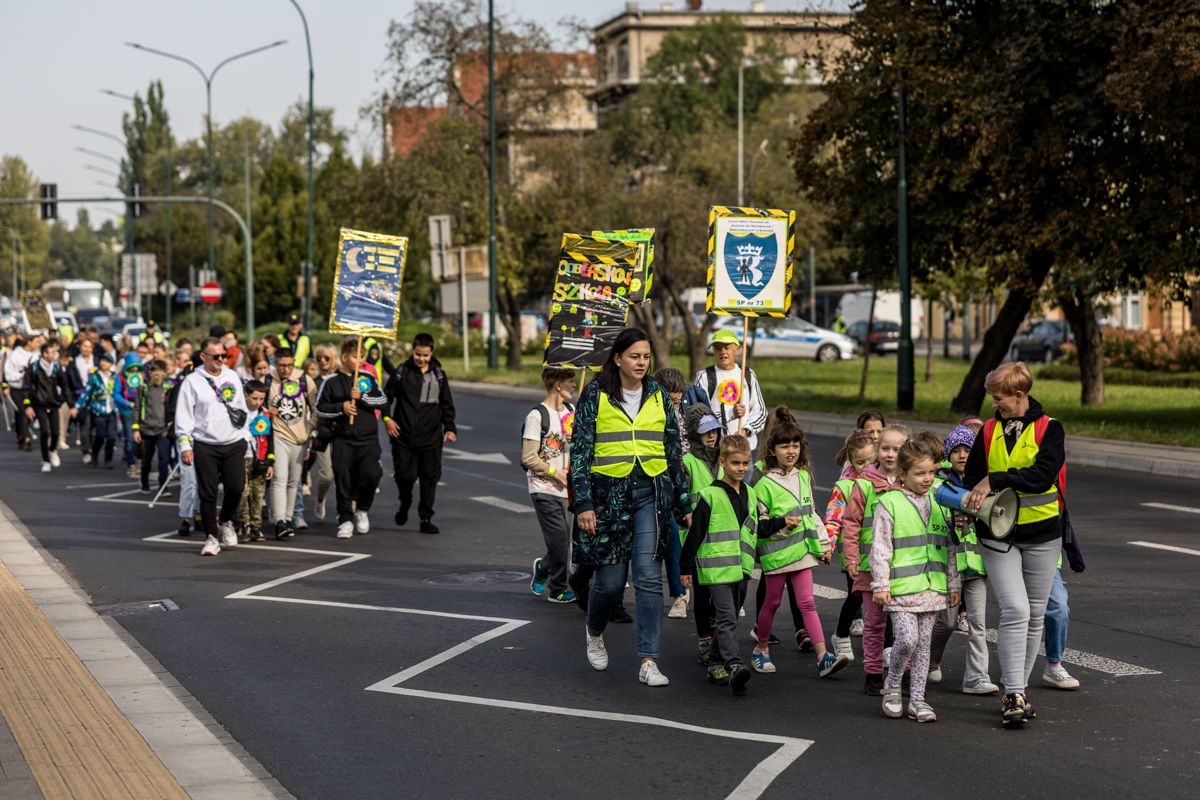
[[0, 564, 187, 800]]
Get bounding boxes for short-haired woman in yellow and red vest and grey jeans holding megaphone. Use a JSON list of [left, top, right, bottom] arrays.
[[962, 361, 1066, 722]]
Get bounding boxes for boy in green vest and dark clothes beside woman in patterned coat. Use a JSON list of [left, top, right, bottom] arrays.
[[679, 433, 758, 694]]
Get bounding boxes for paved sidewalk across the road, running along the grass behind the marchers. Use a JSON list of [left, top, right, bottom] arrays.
[[450, 380, 1200, 480]]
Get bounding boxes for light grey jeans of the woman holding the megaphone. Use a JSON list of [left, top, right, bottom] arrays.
[[980, 539, 1062, 694]]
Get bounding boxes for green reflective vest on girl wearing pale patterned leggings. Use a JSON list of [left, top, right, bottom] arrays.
[[878, 492, 950, 595]]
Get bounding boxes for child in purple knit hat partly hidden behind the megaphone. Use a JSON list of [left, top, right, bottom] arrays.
[[929, 422, 1000, 694]]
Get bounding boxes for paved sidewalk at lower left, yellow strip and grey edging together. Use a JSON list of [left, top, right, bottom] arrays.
[[0, 503, 289, 800]]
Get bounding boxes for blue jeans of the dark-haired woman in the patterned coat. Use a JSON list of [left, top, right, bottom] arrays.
[[588, 488, 679, 658]]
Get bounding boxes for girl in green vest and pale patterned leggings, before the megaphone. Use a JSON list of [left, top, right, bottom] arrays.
[[869, 439, 961, 722]]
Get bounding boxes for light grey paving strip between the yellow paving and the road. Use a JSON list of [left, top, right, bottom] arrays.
[[0, 501, 294, 800]]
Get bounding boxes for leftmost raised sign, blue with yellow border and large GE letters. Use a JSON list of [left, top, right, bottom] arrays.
[[329, 228, 408, 339]]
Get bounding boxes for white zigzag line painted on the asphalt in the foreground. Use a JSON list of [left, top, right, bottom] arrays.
[[143, 527, 814, 800]]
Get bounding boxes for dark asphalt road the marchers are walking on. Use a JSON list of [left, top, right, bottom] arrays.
[[0, 397, 1200, 800]]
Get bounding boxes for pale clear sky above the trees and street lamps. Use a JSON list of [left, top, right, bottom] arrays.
[[0, 0, 841, 224]]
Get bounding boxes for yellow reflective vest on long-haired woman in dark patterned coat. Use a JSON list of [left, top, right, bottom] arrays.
[[592, 392, 667, 477]]
